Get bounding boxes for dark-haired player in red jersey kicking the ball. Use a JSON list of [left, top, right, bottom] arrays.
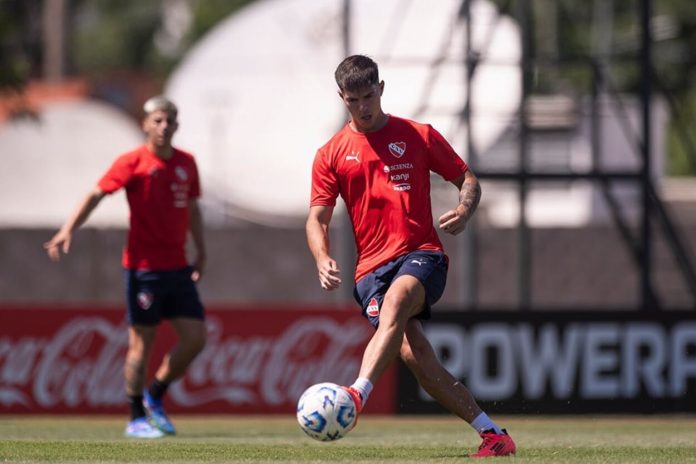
[[306, 55, 515, 457]]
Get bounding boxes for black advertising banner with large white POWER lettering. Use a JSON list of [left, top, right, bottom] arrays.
[[399, 311, 696, 414]]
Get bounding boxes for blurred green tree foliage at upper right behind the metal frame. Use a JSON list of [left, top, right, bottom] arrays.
[[493, 0, 696, 175]]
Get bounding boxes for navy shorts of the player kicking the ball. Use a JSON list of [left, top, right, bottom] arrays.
[[353, 250, 448, 328]]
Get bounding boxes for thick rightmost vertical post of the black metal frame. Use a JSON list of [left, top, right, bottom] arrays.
[[640, 0, 657, 310]]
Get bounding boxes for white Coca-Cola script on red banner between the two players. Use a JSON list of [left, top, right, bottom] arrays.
[[169, 317, 368, 406]]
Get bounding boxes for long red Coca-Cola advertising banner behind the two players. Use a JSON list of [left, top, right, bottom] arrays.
[[0, 307, 396, 414]]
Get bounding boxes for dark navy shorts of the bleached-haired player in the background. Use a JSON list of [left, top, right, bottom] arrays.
[[124, 267, 205, 325]]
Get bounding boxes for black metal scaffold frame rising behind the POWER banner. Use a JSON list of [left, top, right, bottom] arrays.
[[460, 0, 696, 310]]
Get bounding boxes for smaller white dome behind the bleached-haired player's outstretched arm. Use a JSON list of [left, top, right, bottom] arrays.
[[0, 100, 144, 228]]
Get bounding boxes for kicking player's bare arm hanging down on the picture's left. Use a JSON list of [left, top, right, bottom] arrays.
[[306, 206, 341, 290]]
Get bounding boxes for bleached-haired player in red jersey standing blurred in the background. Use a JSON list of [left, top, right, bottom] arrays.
[[44, 96, 206, 438]]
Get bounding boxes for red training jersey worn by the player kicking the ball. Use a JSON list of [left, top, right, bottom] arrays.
[[310, 116, 467, 281]]
